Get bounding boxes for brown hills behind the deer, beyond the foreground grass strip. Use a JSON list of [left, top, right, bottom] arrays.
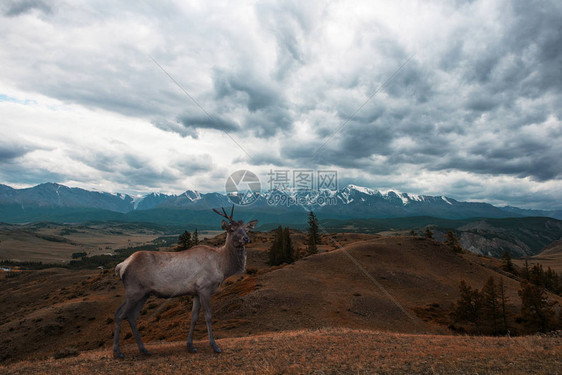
[[0, 233, 562, 369]]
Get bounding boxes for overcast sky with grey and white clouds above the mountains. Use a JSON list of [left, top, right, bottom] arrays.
[[0, 0, 562, 209]]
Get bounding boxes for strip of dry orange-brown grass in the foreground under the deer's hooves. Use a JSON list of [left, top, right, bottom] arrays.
[[0, 329, 562, 374]]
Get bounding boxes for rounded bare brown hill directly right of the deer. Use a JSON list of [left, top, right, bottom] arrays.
[[207, 235, 544, 333]]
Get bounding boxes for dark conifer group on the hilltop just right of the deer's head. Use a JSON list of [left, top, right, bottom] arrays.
[[269, 211, 321, 266]]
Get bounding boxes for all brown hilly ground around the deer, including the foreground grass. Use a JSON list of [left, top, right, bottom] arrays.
[[0, 232, 562, 374]]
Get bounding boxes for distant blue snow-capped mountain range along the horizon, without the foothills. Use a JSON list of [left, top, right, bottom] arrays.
[[0, 183, 562, 223]]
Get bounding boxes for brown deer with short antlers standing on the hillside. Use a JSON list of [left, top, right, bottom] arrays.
[[113, 205, 257, 359]]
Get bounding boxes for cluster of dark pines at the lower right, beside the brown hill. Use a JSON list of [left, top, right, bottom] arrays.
[[450, 277, 562, 335]]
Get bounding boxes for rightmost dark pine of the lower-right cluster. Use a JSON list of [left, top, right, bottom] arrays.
[[519, 281, 556, 332]]
